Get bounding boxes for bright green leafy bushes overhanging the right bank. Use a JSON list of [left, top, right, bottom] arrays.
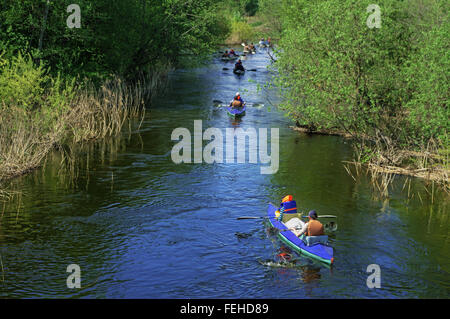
[[268, 0, 449, 154]]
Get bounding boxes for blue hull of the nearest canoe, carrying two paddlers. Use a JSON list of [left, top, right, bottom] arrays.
[[267, 204, 334, 265]]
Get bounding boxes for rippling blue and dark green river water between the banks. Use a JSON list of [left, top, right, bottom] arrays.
[[0, 47, 450, 298]]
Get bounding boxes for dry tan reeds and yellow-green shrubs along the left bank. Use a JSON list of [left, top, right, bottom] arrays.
[[0, 56, 169, 191]]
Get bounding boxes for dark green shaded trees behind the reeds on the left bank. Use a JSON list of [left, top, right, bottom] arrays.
[[0, 0, 228, 81]]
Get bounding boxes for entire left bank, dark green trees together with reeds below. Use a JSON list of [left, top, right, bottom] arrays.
[[0, 0, 229, 195]]
